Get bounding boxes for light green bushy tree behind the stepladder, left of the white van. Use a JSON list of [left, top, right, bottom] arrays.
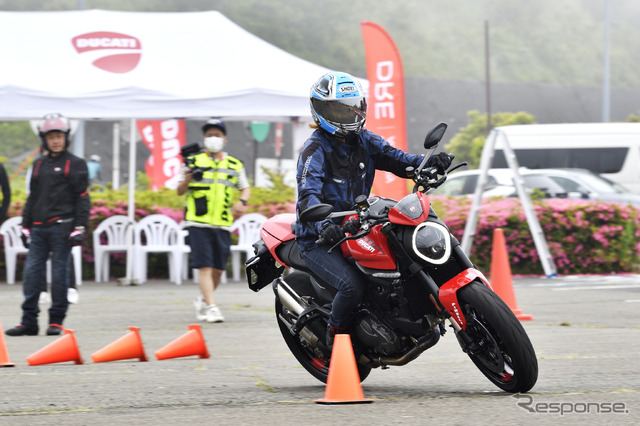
[[445, 110, 535, 168]]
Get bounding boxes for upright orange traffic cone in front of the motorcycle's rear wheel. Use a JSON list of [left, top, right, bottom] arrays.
[[315, 334, 373, 404]]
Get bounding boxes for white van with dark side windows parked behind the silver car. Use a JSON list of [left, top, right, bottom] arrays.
[[489, 123, 640, 194]]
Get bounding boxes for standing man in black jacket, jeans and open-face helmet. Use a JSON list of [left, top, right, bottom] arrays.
[[6, 114, 91, 336]]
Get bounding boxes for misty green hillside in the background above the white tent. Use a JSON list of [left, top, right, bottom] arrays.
[[0, 0, 640, 87]]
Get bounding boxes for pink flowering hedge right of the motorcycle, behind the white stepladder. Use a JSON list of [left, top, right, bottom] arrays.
[[432, 197, 640, 274]]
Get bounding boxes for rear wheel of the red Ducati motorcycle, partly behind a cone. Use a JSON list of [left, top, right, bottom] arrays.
[[275, 272, 371, 383]]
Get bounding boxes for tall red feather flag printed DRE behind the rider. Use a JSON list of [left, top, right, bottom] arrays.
[[361, 21, 408, 199]]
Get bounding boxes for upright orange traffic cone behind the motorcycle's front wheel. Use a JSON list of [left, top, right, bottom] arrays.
[[490, 228, 533, 321]]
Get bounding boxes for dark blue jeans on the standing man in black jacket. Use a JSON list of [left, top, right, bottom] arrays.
[[22, 224, 71, 328]]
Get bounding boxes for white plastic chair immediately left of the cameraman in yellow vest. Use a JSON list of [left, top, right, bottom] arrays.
[[133, 214, 190, 284]]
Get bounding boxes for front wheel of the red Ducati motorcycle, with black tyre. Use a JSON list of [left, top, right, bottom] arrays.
[[458, 282, 538, 393]]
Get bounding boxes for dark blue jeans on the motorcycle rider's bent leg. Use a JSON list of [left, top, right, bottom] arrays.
[[300, 246, 366, 328]]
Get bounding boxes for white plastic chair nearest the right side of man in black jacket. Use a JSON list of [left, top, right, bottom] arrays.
[[93, 215, 136, 283]]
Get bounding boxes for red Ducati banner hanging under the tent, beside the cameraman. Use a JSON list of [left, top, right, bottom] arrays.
[[137, 120, 187, 191]]
